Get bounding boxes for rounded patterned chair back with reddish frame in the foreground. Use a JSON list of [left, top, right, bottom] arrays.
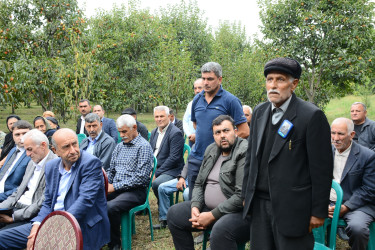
[[33, 211, 83, 250]]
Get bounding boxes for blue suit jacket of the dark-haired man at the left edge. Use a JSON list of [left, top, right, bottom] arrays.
[[0, 147, 30, 202]]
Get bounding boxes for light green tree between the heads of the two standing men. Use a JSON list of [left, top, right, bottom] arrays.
[[211, 22, 266, 107]]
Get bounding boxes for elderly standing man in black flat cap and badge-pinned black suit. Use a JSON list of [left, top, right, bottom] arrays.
[[242, 58, 333, 250]]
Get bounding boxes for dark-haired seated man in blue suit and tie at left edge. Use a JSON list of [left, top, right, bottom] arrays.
[[0, 120, 33, 202]]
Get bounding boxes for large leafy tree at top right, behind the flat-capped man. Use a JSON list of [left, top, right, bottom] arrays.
[[260, 0, 374, 106]]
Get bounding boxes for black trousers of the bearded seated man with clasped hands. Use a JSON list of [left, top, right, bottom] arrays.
[[167, 201, 250, 250]]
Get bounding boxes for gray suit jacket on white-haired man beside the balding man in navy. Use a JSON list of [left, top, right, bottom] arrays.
[[0, 151, 57, 222]]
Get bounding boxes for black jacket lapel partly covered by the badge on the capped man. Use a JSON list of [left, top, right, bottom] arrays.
[[268, 93, 297, 162]]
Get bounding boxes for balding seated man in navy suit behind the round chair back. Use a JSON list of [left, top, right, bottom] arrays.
[[0, 128, 109, 249]]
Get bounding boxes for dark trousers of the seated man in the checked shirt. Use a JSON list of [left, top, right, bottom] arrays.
[[107, 188, 147, 245]]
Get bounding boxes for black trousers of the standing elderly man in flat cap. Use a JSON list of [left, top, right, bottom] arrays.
[[250, 197, 316, 250]]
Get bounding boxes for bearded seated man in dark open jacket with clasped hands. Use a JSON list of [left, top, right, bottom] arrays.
[[167, 115, 250, 250]]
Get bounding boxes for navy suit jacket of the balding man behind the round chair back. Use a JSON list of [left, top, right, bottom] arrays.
[[32, 150, 110, 249]]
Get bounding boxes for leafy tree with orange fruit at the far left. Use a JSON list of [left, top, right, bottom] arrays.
[[0, 0, 107, 119]]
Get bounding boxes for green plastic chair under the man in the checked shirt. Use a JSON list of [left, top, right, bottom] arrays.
[[121, 156, 157, 250]]
